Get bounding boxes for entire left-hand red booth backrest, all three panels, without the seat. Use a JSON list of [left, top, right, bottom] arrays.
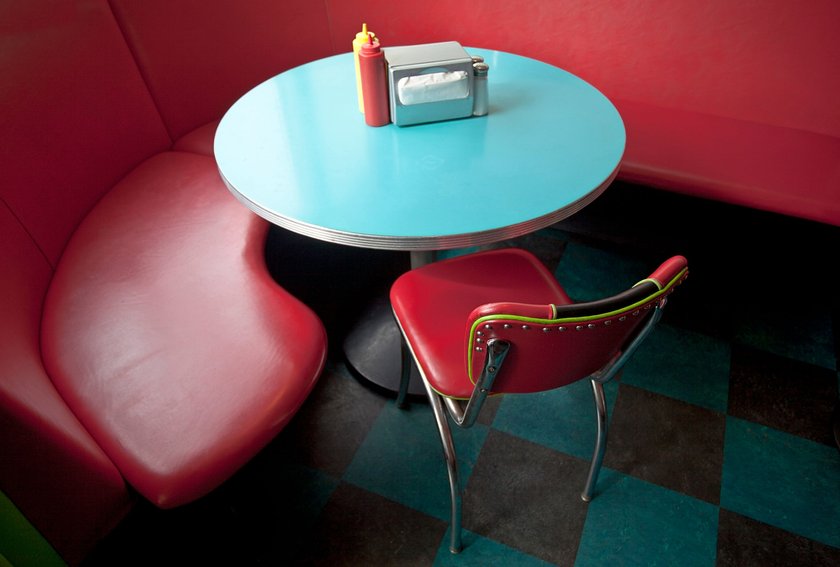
[[0, 0, 330, 564]]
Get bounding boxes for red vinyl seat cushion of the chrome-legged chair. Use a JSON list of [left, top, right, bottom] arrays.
[[391, 249, 571, 398]]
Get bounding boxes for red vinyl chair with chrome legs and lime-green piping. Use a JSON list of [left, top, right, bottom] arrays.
[[390, 248, 688, 553]]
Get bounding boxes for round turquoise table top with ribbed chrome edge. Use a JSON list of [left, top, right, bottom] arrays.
[[215, 47, 626, 250]]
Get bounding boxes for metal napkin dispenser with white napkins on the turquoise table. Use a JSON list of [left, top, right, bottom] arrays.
[[383, 41, 474, 126]]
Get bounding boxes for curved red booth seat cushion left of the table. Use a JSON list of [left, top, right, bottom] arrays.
[[42, 152, 326, 508]]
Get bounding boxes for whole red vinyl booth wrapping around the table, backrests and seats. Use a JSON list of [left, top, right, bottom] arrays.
[[0, 0, 840, 563]]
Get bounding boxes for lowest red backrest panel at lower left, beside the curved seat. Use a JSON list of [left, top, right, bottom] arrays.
[[0, 201, 132, 563]]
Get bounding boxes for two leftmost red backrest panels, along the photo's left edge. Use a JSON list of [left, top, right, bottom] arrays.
[[0, 0, 171, 564]]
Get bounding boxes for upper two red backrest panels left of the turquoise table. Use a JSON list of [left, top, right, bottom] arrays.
[[0, 0, 332, 264]]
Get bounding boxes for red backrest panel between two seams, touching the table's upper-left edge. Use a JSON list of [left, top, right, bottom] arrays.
[[111, 0, 336, 138]]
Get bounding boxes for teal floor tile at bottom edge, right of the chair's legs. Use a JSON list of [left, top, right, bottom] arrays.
[[575, 469, 718, 567]]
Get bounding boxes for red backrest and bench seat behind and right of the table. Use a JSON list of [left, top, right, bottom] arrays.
[[327, 0, 840, 225]]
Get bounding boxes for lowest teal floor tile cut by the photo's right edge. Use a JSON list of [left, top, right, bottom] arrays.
[[721, 417, 840, 547]]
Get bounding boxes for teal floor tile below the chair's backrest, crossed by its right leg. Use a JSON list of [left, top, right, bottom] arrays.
[[493, 380, 618, 461]]
